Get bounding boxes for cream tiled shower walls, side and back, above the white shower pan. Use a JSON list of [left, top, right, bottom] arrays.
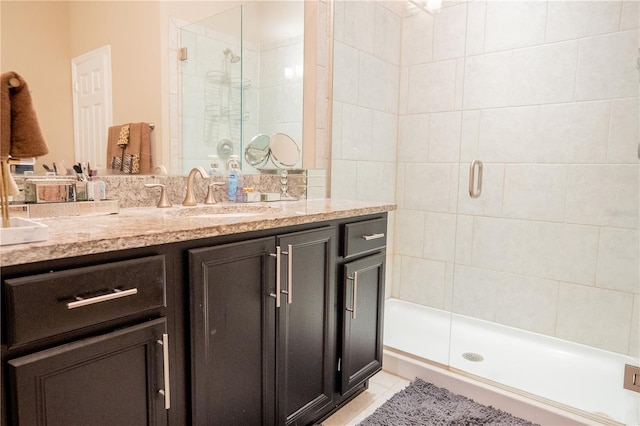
[[332, 1, 640, 356]]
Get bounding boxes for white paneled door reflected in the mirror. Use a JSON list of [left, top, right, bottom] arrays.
[[71, 46, 113, 169]]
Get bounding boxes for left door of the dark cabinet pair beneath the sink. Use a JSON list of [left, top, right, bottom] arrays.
[[189, 238, 276, 425]]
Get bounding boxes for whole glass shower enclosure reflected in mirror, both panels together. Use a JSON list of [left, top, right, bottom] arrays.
[[180, 1, 304, 173]]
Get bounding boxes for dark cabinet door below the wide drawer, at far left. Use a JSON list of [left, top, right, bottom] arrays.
[[8, 319, 168, 426]]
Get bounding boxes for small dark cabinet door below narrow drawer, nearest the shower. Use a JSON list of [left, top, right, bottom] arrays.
[[340, 253, 385, 394]]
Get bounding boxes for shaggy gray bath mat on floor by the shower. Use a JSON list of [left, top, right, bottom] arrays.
[[360, 379, 535, 426]]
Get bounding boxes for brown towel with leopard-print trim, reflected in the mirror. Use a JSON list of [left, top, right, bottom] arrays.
[[107, 123, 151, 174]]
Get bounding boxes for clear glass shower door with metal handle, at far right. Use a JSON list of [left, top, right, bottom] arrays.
[[450, 1, 640, 424]]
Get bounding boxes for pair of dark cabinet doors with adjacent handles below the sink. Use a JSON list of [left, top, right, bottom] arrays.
[[189, 227, 336, 425]]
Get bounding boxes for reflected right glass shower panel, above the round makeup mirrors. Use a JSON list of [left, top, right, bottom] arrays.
[[242, 1, 305, 173]]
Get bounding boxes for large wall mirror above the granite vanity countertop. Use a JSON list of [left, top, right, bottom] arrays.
[[0, 0, 326, 174]]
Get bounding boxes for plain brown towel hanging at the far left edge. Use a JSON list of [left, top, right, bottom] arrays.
[[0, 71, 49, 158]]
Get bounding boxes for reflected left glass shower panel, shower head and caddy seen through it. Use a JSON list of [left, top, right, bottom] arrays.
[[181, 7, 244, 173]]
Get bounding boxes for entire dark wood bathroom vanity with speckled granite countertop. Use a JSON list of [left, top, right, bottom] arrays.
[[0, 200, 394, 425]]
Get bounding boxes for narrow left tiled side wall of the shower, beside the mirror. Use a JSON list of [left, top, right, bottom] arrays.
[[331, 1, 404, 297]]
